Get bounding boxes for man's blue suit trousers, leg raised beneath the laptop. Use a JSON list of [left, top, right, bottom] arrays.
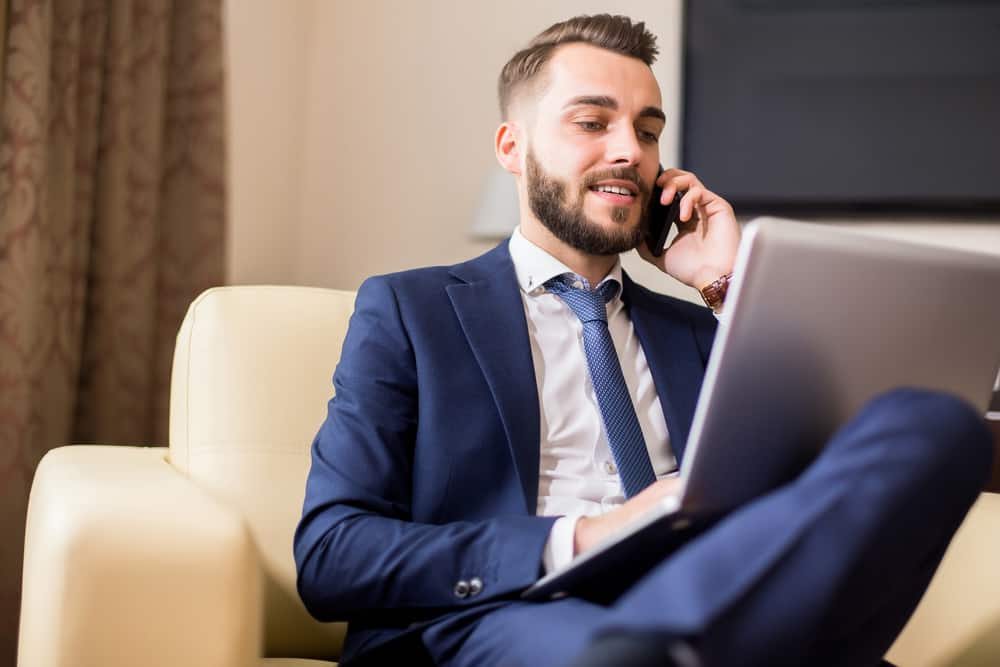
[[422, 389, 993, 667]]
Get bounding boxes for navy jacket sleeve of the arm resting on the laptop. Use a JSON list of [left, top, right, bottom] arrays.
[[294, 278, 555, 621]]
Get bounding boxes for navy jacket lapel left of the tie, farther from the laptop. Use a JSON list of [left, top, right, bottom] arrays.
[[446, 242, 540, 514]]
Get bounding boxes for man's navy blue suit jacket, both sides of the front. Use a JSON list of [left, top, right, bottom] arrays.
[[294, 242, 716, 657]]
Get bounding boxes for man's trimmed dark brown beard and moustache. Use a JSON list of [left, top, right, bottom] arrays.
[[525, 150, 649, 255]]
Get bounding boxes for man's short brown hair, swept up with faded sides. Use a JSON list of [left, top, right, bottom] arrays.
[[497, 14, 660, 120]]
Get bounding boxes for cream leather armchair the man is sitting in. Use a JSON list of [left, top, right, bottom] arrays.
[[18, 287, 1000, 667]]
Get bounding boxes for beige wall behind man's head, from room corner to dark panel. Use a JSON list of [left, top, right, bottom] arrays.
[[296, 0, 680, 287]]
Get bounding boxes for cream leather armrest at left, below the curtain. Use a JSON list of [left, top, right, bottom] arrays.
[[18, 445, 262, 667]]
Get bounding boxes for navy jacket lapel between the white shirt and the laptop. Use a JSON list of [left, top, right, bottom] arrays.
[[622, 275, 705, 462]]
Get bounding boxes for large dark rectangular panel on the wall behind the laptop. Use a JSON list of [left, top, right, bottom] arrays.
[[682, 0, 1000, 213]]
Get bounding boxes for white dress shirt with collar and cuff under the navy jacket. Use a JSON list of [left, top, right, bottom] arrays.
[[509, 228, 677, 571]]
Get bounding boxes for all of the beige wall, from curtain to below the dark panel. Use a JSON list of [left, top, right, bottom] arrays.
[[226, 0, 1000, 298]]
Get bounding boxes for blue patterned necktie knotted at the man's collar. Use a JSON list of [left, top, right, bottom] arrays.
[[545, 274, 656, 498]]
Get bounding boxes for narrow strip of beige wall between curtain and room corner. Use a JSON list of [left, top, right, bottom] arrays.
[[224, 0, 316, 283]]
